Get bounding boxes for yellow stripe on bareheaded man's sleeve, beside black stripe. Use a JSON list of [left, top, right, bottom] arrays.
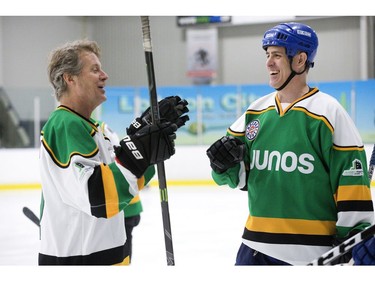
[[100, 164, 120, 218]]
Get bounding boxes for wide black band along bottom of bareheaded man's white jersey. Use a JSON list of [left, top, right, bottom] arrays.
[[38, 240, 129, 265]]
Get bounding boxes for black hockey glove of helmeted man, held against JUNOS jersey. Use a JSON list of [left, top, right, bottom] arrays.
[[206, 136, 245, 174]]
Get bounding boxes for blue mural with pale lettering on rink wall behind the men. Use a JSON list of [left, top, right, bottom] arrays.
[[95, 79, 375, 145]]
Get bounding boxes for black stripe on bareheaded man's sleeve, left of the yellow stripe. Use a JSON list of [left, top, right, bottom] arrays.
[[88, 166, 107, 218]]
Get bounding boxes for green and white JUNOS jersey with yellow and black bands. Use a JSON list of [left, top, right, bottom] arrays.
[[212, 88, 374, 264]]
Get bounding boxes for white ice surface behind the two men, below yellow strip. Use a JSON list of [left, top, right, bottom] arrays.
[[0, 186, 251, 266]]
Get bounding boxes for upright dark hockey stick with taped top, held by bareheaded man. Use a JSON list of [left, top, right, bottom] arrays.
[[141, 16, 174, 265]]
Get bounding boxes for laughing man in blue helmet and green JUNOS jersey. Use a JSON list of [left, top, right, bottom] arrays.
[[207, 22, 375, 265]]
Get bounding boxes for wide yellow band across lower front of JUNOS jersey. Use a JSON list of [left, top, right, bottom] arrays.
[[246, 216, 336, 235]]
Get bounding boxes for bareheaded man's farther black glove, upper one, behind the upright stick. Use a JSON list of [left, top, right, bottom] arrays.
[[126, 96, 189, 135]]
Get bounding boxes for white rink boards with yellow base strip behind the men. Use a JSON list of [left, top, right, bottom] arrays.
[[0, 144, 375, 190]]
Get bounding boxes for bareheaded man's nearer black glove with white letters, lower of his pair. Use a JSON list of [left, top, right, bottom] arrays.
[[115, 122, 177, 178]]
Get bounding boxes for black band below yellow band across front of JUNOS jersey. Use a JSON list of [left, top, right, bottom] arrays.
[[242, 228, 333, 246]]
